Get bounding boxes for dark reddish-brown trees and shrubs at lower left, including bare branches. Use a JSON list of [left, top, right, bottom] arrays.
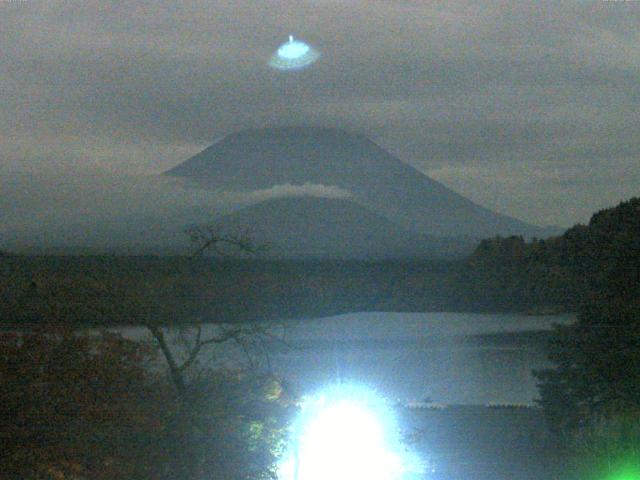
[[0, 230, 289, 480]]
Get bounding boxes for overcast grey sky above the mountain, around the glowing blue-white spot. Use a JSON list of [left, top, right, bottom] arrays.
[[0, 0, 640, 226]]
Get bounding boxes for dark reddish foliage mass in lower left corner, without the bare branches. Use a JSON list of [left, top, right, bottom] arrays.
[[0, 328, 287, 480]]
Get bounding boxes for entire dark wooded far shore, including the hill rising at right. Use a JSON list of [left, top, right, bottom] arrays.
[[0, 199, 640, 325]]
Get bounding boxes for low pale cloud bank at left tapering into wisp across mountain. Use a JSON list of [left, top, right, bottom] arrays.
[[0, 171, 350, 246]]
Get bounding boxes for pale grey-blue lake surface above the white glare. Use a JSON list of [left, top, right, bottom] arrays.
[[117, 312, 574, 405]]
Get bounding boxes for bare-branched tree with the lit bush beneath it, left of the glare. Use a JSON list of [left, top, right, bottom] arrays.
[[139, 226, 287, 480]]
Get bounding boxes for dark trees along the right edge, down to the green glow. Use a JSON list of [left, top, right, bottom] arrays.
[[537, 199, 640, 479]]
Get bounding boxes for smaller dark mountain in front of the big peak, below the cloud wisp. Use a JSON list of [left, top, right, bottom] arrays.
[[212, 197, 475, 259]]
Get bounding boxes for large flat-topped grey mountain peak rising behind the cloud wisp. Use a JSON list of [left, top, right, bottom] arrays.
[[166, 127, 548, 238]]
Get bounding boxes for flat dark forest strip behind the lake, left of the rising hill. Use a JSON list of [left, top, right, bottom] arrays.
[[0, 255, 455, 325]]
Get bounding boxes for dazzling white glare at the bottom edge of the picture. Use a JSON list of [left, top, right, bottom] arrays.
[[279, 387, 410, 480]]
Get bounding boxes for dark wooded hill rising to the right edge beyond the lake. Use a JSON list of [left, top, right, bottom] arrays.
[[454, 198, 640, 313]]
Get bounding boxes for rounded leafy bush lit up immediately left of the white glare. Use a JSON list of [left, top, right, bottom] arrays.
[[159, 371, 290, 480]]
